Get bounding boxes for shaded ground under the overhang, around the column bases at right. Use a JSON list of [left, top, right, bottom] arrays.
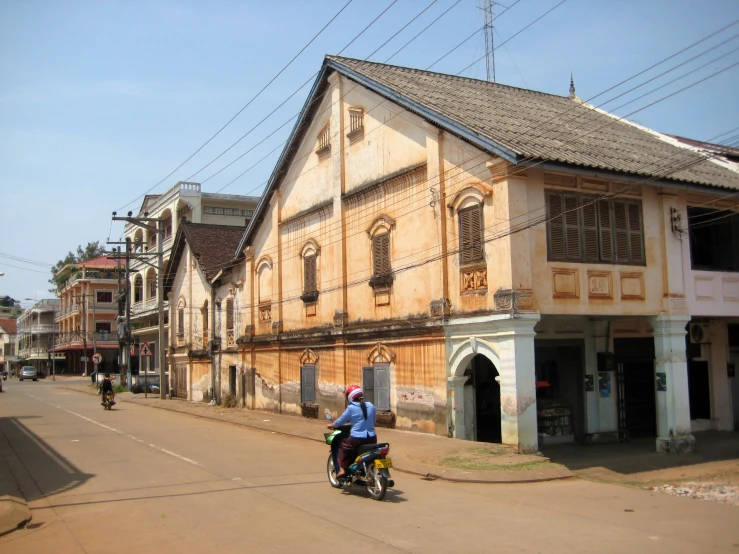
[[541, 431, 739, 474]]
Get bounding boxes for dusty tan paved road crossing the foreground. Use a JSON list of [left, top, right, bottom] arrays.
[[0, 381, 739, 554]]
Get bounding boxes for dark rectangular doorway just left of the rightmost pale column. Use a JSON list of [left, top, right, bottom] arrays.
[[613, 338, 657, 438]]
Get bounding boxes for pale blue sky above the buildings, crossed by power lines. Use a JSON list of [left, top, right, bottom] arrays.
[[0, 0, 739, 307]]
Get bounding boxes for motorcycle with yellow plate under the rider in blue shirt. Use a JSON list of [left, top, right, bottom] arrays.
[[323, 414, 395, 500]]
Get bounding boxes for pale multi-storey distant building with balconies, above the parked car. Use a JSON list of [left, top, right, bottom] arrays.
[[17, 298, 64, 375]]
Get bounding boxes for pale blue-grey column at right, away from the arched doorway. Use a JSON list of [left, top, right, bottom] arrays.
[[650, 315, 695, 453]]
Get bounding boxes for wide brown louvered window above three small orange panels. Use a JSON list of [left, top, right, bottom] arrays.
[[547, 191, 646, 265]]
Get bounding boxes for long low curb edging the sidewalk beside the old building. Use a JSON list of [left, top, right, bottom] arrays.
[[63, 386, 575, 485]]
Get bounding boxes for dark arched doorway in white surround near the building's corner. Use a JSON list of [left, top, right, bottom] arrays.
[[465, 354, 503, 443]]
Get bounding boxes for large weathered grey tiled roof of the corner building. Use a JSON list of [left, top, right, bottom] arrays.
[[327, 56, 739, 189]]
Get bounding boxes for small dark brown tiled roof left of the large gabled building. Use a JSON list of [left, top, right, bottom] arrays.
[[181, 222, 244, 280]]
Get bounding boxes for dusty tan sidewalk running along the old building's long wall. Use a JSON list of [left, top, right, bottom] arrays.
[[63, 379, 572, 483]]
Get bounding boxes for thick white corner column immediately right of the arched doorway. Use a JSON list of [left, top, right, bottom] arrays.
[[498, 314, 539, 453]]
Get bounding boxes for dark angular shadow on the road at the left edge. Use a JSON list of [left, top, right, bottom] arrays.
[[0, 416, 93, 502]]
